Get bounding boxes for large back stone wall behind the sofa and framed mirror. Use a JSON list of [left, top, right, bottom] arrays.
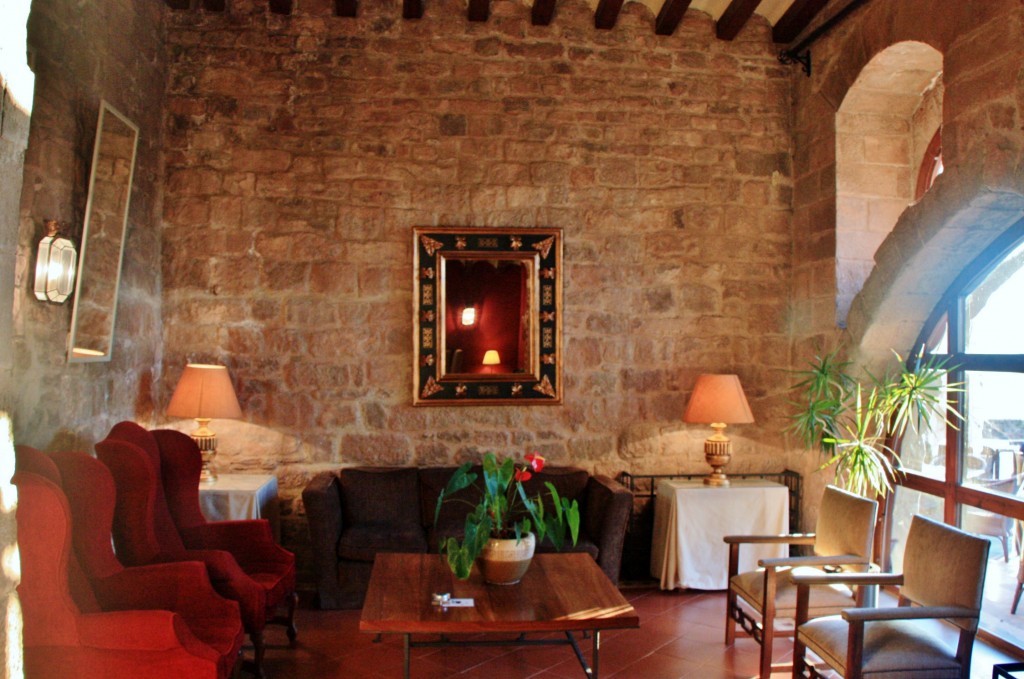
[[161, 0, 792, 577]]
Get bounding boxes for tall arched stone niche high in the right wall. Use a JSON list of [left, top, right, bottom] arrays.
[[836, 41, 942, 327]]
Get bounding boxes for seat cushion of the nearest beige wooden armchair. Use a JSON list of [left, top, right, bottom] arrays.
[[799, 616, 961, 679]]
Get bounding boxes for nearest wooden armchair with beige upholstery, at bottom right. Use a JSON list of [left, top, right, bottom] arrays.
[[793, 516, 990, 679]]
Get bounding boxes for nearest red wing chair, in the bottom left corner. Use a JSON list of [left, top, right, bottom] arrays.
[[13, 471, 237, 679]]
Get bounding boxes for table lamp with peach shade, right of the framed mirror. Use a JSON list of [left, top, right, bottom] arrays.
[[683, 375, 754, 485]]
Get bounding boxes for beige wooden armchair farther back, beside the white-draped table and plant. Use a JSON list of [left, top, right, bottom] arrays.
[[725, 485, 879, 678]]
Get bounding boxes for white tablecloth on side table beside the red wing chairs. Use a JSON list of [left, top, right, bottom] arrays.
[[199, 474, 281, 542]]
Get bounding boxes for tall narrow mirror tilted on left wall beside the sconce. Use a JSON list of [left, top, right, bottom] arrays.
[[68, 101, 138, 363]]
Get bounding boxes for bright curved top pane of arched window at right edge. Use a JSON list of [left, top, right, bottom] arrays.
[[966, 243, 1024, 356]]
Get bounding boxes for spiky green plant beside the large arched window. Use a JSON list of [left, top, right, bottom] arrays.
[[786, 347, 963, 497]]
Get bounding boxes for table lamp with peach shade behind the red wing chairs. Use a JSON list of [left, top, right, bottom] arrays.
[[167, 364, 242, 483]]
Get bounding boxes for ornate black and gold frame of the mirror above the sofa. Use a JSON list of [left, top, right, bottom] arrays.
[[413, 226, 562, 406]]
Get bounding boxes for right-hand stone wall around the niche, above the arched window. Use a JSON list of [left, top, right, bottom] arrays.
[[792, 0, 1024, 520]]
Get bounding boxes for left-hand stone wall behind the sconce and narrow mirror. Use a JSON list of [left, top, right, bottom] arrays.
[[10, 0, 165, 452]]
